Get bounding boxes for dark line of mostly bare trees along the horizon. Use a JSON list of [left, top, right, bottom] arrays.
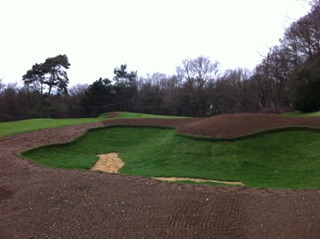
[[0, 0, 320, 120]]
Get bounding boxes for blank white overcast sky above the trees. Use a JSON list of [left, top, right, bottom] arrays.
[[0, 0, 310, 85]]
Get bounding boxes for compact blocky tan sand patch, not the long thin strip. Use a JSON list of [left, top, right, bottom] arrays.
[[91, 153, 124, 173]]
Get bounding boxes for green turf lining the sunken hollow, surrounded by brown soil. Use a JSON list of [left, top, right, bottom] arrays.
[[22, 126, 320, 189]]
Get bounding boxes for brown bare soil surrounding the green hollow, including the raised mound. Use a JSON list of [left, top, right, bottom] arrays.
[[0, 114, 320, 239]]
